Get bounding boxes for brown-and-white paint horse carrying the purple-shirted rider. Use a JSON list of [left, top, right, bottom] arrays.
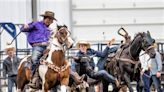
[[17, 26, 74, 92]]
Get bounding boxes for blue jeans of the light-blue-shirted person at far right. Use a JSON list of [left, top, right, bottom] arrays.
[[150, 75, 162, 92]]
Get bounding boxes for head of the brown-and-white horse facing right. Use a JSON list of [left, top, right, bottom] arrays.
[[55, 25, 74, 48]]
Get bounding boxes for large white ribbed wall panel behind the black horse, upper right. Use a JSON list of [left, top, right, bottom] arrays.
[[71, 0, 164, 41]]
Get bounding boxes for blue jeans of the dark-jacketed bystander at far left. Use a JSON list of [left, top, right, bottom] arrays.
[[8, 75, 17, 92]]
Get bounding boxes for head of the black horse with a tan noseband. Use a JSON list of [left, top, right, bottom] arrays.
[[141, 31, 155, 58]]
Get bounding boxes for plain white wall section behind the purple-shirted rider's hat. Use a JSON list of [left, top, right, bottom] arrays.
[[37, 0, 71, 27]]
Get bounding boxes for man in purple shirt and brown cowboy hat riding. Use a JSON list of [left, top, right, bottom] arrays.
[[21, 11, 56, 88]]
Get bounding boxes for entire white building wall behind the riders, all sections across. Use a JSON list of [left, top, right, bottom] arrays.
[[0, 0, 164, 48]]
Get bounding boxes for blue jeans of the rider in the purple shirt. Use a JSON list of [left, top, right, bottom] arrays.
[[31, 46, 47, 75]]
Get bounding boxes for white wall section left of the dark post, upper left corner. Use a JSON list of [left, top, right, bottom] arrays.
[[0, 0, 32, 24]]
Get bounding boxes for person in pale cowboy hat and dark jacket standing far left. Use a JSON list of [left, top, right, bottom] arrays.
[[3, 45, 20, 92]]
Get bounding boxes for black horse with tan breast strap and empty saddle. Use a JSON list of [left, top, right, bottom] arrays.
[[104, 31, 155, 92]]
